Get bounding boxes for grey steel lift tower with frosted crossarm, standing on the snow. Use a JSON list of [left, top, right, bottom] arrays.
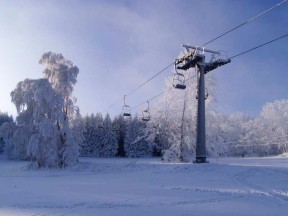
[[175, 45, 231, 163]]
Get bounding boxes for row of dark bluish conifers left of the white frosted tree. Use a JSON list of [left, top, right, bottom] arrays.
[[80, 113, 161, 157]]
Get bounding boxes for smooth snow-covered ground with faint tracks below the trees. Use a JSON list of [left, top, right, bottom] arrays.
[[0, 156, 288, 216]]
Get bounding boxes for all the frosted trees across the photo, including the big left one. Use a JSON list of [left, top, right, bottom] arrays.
[[0, 52, 288, 168]]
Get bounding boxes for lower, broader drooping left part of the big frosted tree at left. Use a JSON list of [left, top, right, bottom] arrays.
[[11, 79, 69, 167]]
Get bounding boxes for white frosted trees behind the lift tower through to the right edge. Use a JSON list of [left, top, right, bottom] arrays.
[[149, 70, 288, 161]]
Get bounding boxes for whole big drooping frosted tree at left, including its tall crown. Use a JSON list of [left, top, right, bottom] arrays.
[[9, 52, 79, 167]]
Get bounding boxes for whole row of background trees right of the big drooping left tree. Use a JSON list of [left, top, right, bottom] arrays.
[[77, 68, 288, 161]]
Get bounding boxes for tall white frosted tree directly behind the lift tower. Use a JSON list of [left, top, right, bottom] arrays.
[[149, 66, 216, 161]]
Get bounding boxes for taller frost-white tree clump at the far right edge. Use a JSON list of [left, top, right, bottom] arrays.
[[238, 100, 288, 156]]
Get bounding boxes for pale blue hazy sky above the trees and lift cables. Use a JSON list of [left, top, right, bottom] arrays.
[[0, 0, 288, 116]]
